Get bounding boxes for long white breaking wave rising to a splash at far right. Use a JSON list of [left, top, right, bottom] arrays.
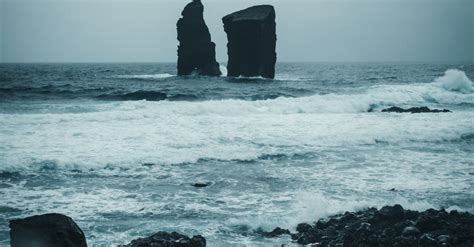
[[115, 70, 474, 116]]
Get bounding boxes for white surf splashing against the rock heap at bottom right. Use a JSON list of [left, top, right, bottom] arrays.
[[226, 189, 473, 232]]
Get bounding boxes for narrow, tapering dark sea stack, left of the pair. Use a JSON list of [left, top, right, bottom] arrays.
[[177, 0, 221, 76]]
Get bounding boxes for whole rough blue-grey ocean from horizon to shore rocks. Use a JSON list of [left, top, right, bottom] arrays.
[[0, 63, 474, 246]]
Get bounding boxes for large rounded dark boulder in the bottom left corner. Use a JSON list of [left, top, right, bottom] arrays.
[[10, 214, 87, 247]]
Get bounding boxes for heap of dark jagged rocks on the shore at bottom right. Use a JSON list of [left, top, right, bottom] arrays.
[[266, 205, 474, 247]]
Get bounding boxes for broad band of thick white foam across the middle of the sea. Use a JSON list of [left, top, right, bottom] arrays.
[[0, 70, 474, 172]]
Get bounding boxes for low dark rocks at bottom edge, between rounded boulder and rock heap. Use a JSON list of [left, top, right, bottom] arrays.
[[125, 232, 206, 247]]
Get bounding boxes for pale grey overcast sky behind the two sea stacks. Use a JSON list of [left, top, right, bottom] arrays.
[[0, 0, 474, 62]]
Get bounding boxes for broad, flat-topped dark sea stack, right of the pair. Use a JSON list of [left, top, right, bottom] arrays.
[[222, 5, 277, 79]]
